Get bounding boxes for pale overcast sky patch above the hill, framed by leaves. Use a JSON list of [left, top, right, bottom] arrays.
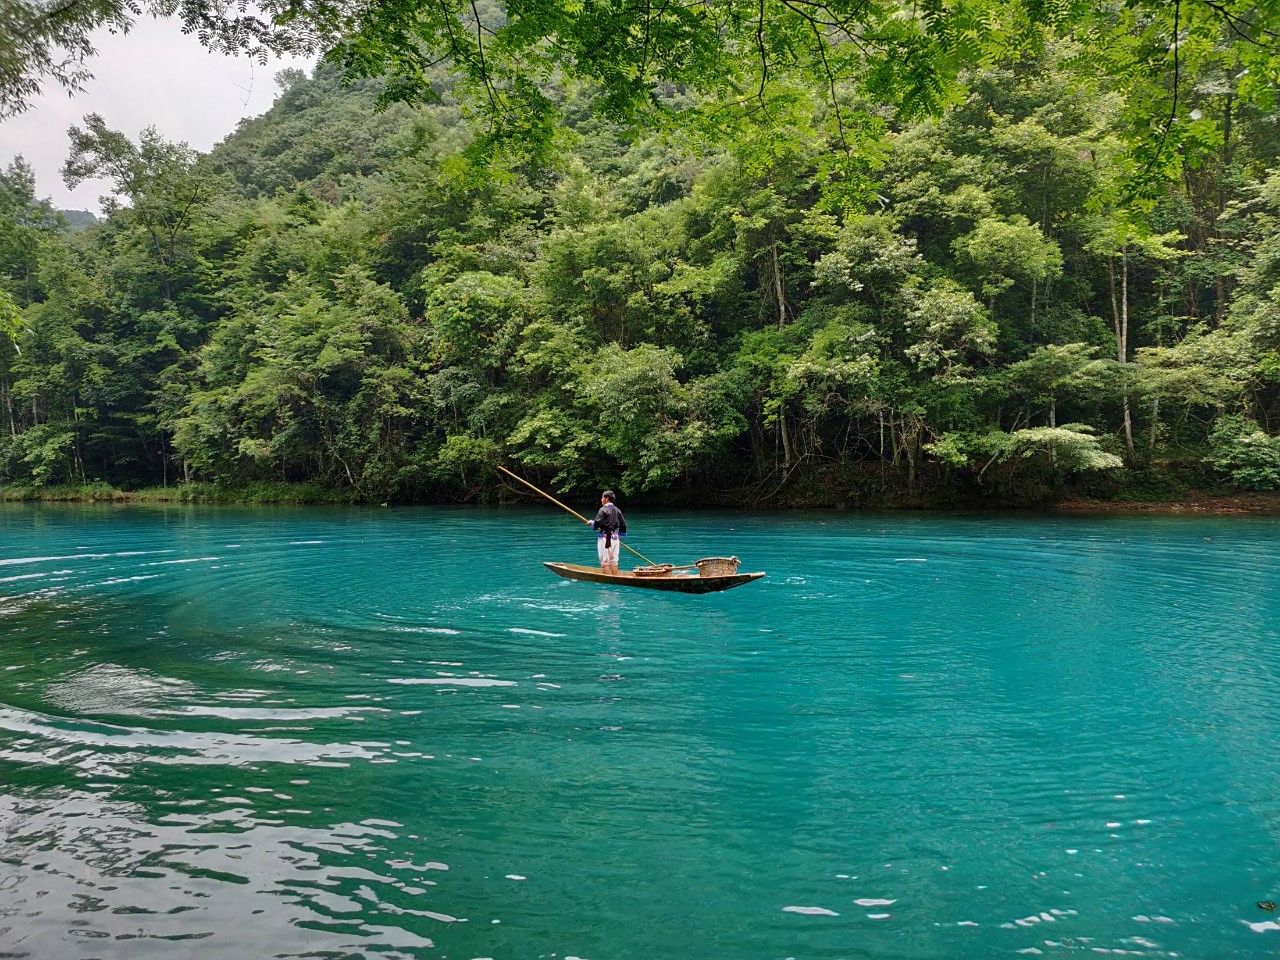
[[0, 17, 310, 214]]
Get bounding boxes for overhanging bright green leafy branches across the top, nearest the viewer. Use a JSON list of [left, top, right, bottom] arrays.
[[10, 0, 1280, 188]]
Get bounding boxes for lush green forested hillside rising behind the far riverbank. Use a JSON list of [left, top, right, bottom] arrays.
[[0, 38, 1280, 506]]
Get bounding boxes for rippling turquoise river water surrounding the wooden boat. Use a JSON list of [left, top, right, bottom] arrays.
[[0, 506, 1280, 960]]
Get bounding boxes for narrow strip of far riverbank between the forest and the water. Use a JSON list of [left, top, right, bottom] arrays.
[[0, 483, 1280, 516]]
